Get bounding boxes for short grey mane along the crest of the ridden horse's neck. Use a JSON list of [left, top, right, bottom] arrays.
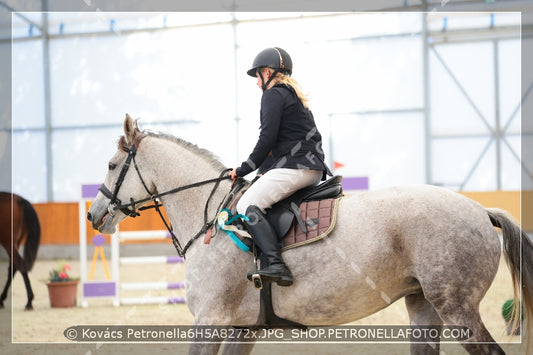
[[118, 128, 226, 171]]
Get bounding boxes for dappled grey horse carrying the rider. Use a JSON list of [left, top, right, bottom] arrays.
[[88, 115, 533, 354]]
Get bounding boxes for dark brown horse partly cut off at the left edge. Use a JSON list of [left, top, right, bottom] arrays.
[[0, 192, 41, 310]]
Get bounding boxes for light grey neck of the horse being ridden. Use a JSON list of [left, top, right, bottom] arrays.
[[141, 137, 230, 250]]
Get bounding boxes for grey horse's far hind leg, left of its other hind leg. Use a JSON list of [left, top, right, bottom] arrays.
[[405, 293, 443, 355]]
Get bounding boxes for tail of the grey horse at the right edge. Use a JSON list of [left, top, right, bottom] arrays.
[[487, 208, 533, 348]]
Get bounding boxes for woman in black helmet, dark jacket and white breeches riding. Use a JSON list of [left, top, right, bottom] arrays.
[[229, 47, 331, 286]]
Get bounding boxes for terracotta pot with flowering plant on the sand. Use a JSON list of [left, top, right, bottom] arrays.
[[46, 262, 79, 307]]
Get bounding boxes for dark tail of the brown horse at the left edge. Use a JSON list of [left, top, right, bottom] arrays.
[[18, 196, 41, 272]]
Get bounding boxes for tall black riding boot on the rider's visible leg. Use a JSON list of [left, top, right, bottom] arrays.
[[244, 206, 292, 286]]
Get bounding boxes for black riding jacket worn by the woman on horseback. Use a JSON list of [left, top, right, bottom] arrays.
[[236, 84, 332, 179]]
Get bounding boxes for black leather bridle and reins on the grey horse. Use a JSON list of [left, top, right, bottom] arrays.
[[99, 144, 231, 257]]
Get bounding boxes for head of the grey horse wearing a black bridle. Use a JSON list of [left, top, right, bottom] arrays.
[[87, 114, 155, 234]]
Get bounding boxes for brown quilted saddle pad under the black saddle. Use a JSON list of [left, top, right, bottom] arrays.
[[281, 198, 340, 251]]
